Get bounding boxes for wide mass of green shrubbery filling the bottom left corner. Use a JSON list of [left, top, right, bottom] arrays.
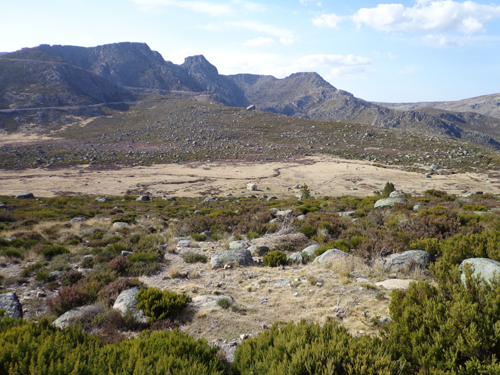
[[0, 313, 226, 375]]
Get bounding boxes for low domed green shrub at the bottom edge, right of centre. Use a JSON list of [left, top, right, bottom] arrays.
[[234, 321, 400, 375]]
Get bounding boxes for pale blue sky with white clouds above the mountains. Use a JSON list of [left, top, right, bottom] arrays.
[[0, 0, 500, 103]]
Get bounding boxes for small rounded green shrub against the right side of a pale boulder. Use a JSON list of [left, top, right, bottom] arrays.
[[136, 288, 191, 322]]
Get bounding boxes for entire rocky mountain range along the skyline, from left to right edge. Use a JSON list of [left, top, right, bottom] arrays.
[[0, 42, 500, 149]]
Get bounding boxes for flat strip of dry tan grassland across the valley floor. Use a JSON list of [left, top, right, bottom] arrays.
[[0, 156, 500, 197]]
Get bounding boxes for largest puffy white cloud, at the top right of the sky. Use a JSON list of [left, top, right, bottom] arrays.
[[352, 0, 500, 35]]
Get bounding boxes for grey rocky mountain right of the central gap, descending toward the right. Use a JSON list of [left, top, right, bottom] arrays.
[[228, 73, 500, 148]]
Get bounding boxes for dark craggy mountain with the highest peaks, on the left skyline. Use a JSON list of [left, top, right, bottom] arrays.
[[4, 42, 247, 106]]
